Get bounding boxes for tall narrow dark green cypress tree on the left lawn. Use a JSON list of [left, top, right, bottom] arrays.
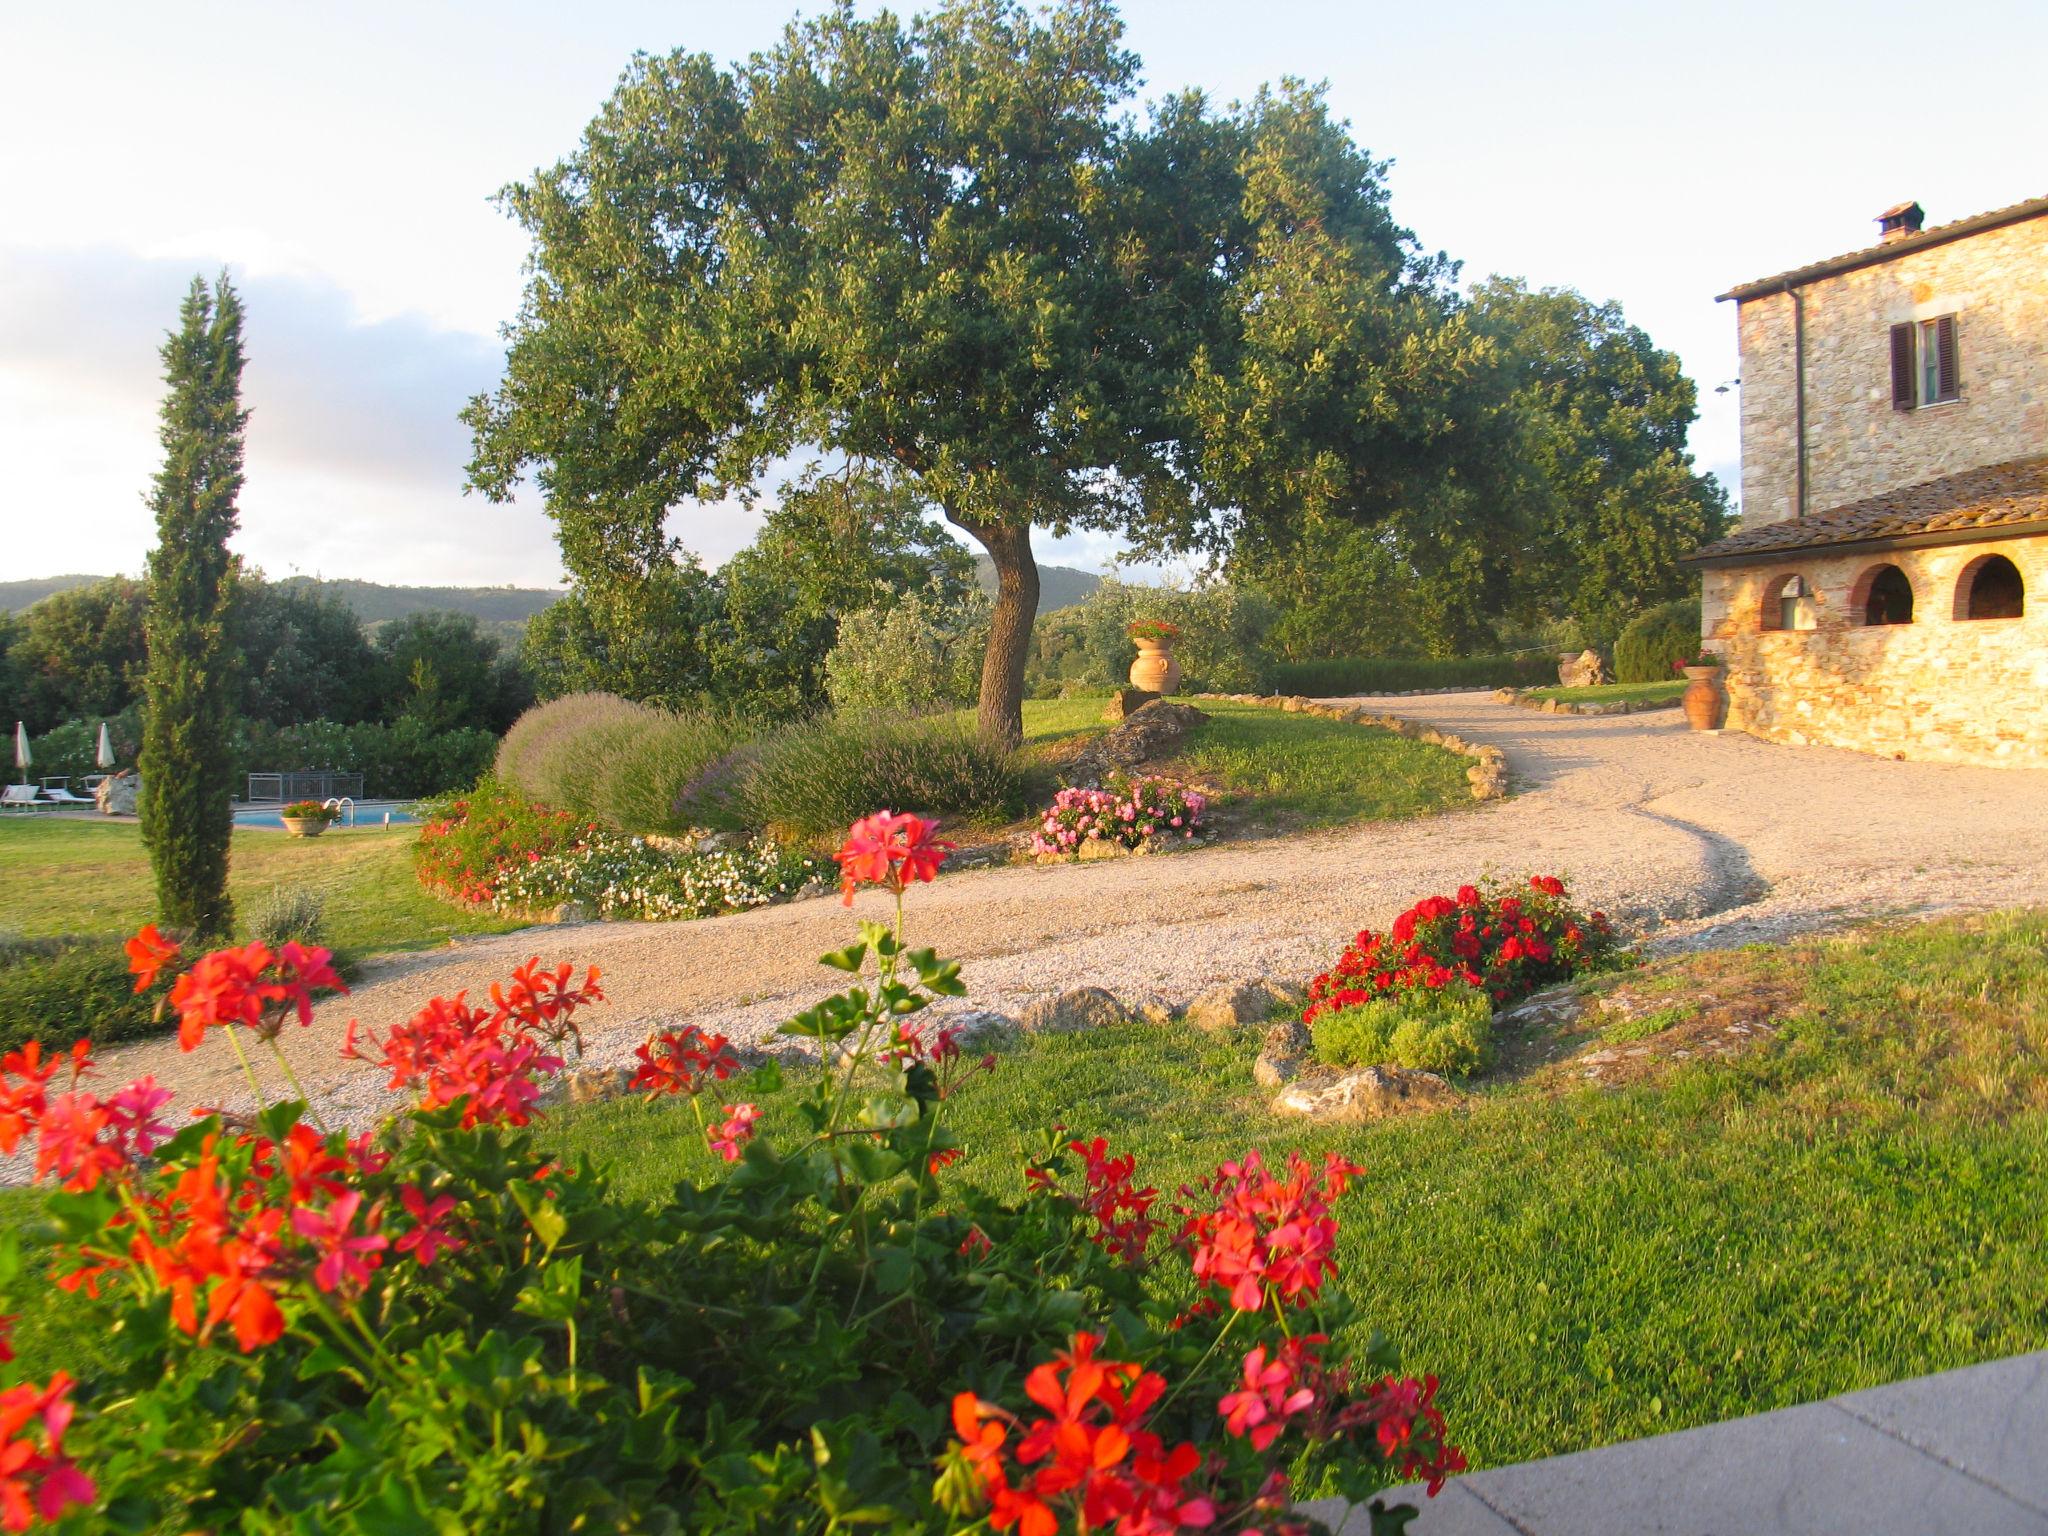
[[139, 272, 248, 938]]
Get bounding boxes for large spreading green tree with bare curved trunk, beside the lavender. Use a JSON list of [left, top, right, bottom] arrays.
[[465, 0, 1483, 739]]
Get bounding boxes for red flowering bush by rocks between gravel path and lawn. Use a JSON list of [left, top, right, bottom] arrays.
[[1303, 874, 1614, 1026]]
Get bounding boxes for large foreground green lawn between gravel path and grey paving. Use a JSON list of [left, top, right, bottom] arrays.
[[549, 913, 2048, 1466]]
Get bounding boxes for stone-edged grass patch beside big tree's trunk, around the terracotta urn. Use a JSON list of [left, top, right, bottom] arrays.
[[1007, 698, 1470, 831]]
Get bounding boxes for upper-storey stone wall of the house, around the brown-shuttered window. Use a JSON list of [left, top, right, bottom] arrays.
[[1737, 217, 2048, 528]]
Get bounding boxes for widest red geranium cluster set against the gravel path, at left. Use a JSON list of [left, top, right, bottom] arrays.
[[342, 958, 604, 1126]]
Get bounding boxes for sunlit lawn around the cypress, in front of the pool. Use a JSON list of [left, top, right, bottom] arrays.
[[0, 817, 520, 954]]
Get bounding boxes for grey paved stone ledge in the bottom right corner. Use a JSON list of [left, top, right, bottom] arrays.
[[1309, 1352, 2048, 1536]]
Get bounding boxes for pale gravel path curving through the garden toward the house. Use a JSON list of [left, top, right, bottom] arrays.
[[83, 694, 2048, 1124]]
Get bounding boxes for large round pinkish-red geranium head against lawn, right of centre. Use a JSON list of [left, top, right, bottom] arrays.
[[1180, 1151, 1364, 1313]]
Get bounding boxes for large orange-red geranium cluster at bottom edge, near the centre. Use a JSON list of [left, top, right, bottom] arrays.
[[952, 1333, 1217, 1536]]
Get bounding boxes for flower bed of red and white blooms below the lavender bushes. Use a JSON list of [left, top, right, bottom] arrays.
[[414, 780, 825, 922]]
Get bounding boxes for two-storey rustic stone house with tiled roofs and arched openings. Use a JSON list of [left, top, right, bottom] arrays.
[[1692, 199, 2048, 766]]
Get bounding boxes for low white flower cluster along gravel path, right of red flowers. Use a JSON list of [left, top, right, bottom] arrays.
[[492, 836, 827, 922]]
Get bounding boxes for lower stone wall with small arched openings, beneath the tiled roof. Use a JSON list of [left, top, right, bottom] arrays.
[[1700, 537, 2048, 768]]
